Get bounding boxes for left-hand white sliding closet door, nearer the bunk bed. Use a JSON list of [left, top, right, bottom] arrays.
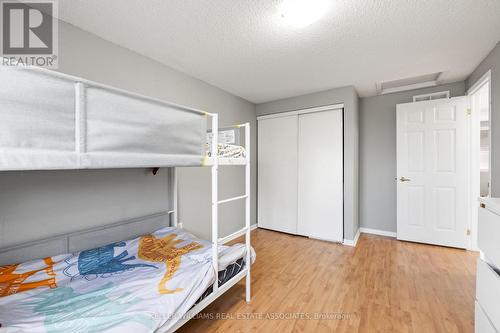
[[257, 115, 298, 234]]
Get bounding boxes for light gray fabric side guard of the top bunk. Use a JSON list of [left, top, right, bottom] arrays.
[[0, 66, 207, 171]]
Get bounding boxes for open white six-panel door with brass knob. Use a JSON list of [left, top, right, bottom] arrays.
[[396, 97, 468, 248]]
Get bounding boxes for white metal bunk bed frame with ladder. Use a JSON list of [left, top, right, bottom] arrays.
[[0, 67, 251, 332]]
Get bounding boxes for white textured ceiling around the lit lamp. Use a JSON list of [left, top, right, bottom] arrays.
[[59, 0, 500, 103]]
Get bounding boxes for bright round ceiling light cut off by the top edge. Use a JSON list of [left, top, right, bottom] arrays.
[[279, 0, 331, 28]]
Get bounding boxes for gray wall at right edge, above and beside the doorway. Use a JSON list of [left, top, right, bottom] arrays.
[[465, 42, 500, 196]]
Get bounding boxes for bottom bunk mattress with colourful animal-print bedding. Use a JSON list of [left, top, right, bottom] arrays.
[[0, 227, 255, 332]]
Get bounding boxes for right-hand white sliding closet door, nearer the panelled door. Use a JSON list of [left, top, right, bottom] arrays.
[[298, 109, 344, 242]]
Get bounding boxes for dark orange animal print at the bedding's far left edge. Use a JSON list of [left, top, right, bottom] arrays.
[[0, 257, 56, 297]]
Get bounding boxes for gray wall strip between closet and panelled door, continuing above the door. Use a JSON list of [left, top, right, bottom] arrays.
[[359, 82, 465, 232]]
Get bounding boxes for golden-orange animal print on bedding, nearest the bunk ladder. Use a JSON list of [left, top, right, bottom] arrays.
[[138, 234, 203, 294]]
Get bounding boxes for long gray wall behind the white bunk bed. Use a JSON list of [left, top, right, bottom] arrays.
[[0, 23, 256, 247]]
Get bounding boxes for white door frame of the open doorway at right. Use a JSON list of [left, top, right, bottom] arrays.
[[466, 69, 492, 251]]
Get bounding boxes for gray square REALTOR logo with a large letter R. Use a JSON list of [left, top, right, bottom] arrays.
[[0, 0, 58, 68]]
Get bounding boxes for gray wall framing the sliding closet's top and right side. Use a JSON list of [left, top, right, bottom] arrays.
[[256, 87, 359, 240]]
